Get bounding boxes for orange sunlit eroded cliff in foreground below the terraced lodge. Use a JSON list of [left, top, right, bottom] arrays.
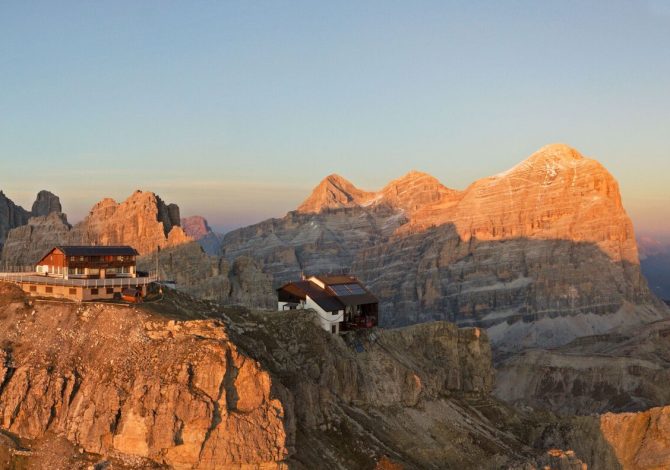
[[0, 284, 294, 469]]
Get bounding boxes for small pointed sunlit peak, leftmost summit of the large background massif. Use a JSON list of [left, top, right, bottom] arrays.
[[298, 174, 374, 213]]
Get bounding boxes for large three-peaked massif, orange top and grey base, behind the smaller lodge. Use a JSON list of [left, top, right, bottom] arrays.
[[223, 144, 667, 350]]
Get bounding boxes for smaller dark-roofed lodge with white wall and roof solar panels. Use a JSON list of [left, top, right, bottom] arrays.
[[277, 275, 379, 333]]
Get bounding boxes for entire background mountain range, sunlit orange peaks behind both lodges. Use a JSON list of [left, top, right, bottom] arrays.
[[2, 144, 668, 352]]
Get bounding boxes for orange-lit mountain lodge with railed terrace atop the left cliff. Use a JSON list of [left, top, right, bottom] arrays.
[[2, 245, 156, 302]]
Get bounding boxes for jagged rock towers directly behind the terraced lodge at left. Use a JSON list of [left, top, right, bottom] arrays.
[[2, 191, 192, 266]]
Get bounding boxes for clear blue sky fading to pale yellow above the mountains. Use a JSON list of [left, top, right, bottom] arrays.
[[0, 0, 670, 238]]
